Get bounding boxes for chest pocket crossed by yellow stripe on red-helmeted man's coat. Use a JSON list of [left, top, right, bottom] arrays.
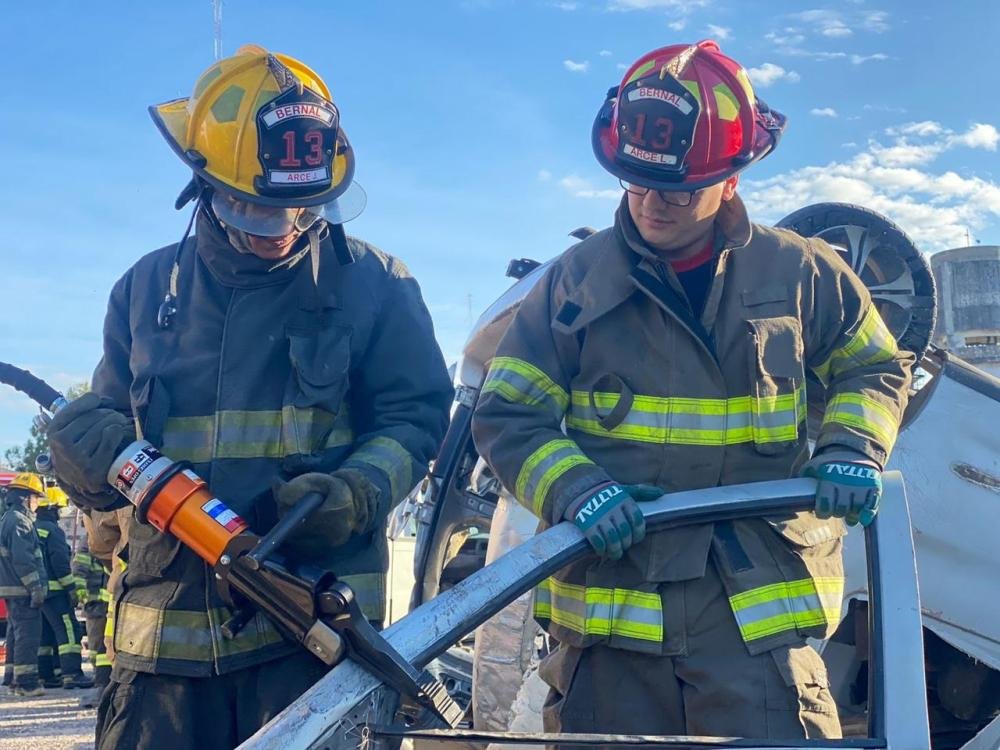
[[747, 315, 806, 455]]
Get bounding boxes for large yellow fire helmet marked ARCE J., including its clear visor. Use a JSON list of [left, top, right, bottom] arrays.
[[149, 45, 365, 235]]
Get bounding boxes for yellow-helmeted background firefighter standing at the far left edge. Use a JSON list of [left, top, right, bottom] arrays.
[[0, 472, 48, 696]]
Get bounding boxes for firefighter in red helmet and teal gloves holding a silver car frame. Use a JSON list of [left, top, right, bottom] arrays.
[[473, 41, 914, 739]]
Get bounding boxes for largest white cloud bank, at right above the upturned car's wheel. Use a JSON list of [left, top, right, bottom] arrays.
[[742, 121, 1000, 251]]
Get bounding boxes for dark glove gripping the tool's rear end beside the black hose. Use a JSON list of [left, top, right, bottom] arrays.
[[48, 393, 135, 494]]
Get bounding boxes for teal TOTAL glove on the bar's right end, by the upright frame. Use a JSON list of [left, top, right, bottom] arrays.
[[802, 451, 882, 526]]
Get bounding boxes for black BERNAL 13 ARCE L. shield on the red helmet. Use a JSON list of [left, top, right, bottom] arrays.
[[616, 70, 701, 190]]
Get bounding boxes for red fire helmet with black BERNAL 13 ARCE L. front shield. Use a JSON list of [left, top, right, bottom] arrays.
[[592, 40, 785, 191]]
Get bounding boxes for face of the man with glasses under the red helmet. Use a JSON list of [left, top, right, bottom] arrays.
[[627, 177, 737, 257]]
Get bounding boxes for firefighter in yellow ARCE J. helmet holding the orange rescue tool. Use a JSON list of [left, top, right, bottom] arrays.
[[49, 46, 451, 748]]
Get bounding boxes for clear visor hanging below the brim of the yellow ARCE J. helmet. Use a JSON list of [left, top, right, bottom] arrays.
[[212, 182, 367, 237]]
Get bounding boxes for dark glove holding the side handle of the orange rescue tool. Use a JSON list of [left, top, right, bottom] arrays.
[[274, 469, 379, 557]]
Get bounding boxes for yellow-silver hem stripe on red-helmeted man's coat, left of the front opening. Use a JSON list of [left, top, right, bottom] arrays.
[[535, 578, 663, 643]]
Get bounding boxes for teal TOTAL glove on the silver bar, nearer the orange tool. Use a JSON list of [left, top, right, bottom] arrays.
[[563, 482, 648, 560]]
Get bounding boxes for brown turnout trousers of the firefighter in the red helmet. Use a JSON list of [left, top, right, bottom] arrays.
[[539, 560, 841, 740]]
